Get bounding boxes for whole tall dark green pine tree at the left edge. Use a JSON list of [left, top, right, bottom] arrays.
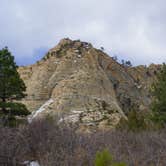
[[0, 47, 29, 125]]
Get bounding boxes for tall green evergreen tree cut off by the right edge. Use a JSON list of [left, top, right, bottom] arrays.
[[152, 64, 166, 125]]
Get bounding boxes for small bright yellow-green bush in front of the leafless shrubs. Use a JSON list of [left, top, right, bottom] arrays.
[[95, 149, 126, 166]]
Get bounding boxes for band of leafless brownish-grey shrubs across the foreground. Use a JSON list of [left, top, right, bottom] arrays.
[[0, 120, 166, 166]]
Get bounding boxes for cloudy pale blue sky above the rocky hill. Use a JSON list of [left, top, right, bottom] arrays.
[[0, 0, 166, 65]]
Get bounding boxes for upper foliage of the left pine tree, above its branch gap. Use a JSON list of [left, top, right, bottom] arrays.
[[0, 48, 26, 100]]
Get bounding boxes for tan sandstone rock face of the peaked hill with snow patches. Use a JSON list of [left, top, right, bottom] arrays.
[[19, 39, 160, 128]]
